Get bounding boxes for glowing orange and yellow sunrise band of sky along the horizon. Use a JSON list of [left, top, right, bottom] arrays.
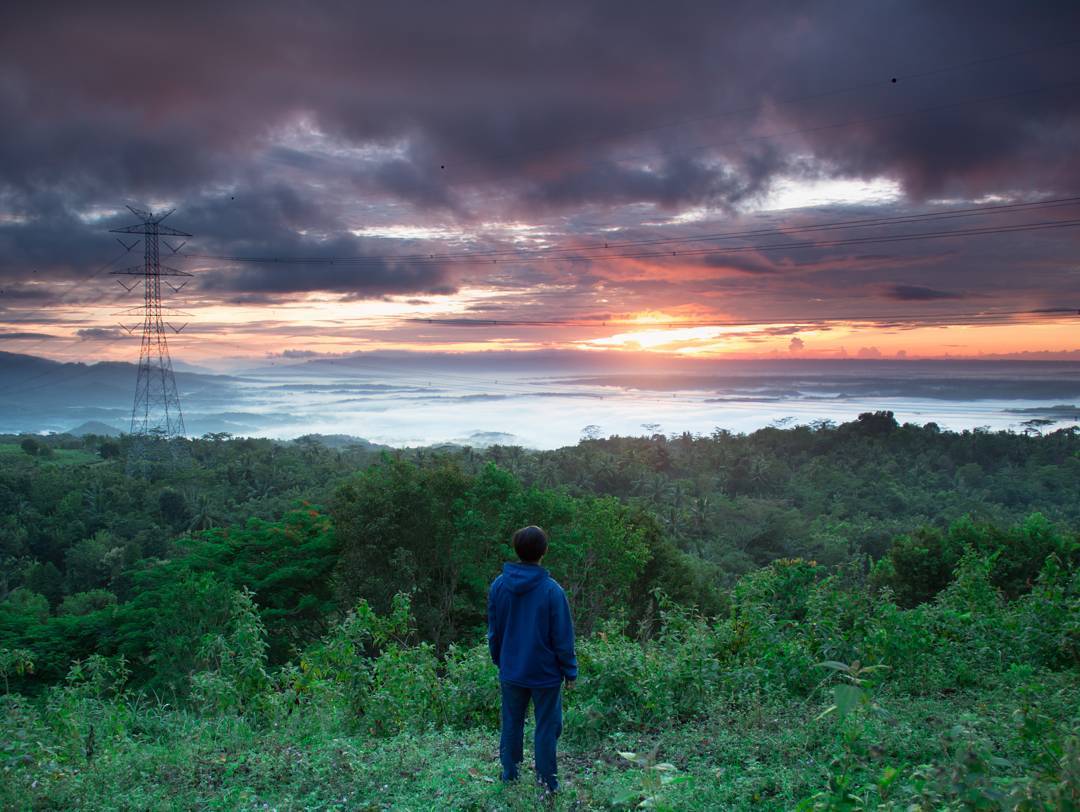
[[4, 287, 1080, 364]]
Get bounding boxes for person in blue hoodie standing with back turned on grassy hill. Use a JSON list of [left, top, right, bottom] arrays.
[[487, 525, 578, 793]]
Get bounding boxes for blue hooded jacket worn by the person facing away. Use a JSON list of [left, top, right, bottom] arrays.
[[487, 564, 578, 688]]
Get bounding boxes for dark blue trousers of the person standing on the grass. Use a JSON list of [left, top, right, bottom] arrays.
[[499, 682, 563, 790]]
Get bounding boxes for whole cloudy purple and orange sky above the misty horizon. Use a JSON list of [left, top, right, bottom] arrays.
[[0, 0, 1080, 365]]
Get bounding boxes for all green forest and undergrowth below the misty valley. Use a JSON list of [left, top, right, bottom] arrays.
[[0, 411, 1080, 809]]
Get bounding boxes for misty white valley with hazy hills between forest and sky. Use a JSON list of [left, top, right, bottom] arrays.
[[6, 352, 1080, 447]]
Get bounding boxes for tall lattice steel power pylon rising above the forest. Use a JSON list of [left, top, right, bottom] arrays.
[[110, 206, 191, 437]]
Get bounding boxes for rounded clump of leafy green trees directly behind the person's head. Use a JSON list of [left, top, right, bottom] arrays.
[[333, 459, 659, 649]]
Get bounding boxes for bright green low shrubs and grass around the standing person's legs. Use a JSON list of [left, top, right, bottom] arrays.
[[0, 555, 1080, 810]]
